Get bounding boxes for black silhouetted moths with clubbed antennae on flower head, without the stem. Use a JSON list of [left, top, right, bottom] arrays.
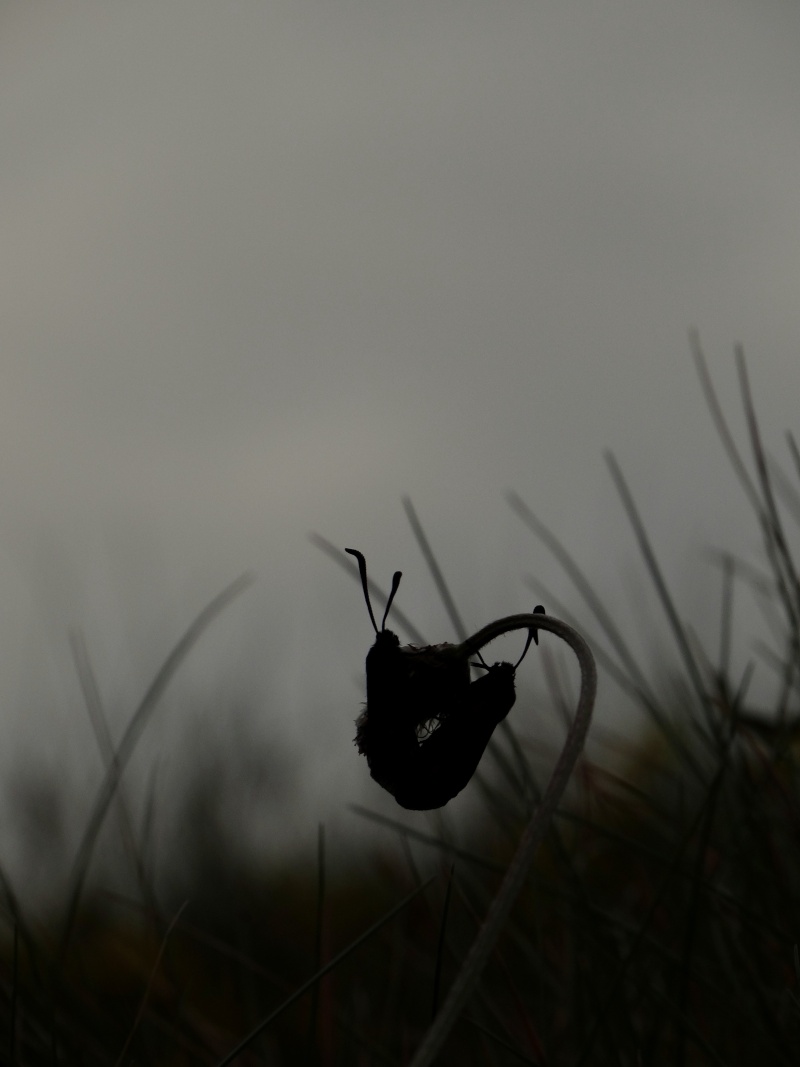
[[345, 548, 544, 811]]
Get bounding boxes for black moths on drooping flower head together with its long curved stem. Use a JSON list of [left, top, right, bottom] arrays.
[[345, 548, 597, 1067]]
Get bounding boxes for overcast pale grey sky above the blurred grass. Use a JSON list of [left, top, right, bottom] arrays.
[[0, 0, 800, 874]]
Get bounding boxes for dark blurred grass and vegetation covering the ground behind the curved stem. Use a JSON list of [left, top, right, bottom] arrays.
[[0, 346, 800, 1067]]
